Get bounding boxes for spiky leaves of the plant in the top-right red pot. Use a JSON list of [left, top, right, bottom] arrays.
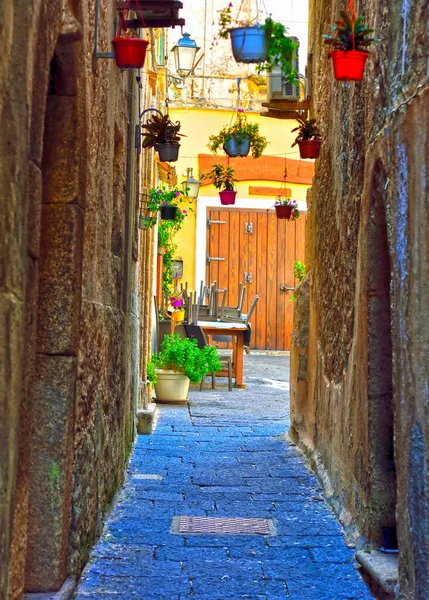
[[322, 10, 380, 52]]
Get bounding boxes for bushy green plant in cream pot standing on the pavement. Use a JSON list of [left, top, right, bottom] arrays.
[[147, 334, 222, 402]]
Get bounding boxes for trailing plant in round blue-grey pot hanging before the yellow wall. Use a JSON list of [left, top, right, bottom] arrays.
[[207, 112, 268, 158]]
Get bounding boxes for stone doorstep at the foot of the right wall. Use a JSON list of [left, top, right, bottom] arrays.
[[356, 550, 398, 600]]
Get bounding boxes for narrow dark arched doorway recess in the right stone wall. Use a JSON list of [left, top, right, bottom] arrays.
[[367, 161, 396, 545]]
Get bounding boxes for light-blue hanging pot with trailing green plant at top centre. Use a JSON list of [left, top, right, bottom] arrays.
[[218, 2, 298, 83]]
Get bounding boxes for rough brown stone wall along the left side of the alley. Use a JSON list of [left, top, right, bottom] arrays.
[[0, 0, 153, 599]]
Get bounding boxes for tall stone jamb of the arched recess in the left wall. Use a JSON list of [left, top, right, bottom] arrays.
[[25, 32, 83, 592]]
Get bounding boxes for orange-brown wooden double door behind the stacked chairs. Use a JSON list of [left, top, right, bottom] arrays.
[[206, 208, 305, 350]]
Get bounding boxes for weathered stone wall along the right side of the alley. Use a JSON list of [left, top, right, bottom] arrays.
[[291, 0, 429, 600]]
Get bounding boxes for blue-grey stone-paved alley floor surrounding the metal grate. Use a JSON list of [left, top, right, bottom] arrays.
[[76, 354, 372, 600]]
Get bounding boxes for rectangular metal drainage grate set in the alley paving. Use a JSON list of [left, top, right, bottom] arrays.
[[171, 517, 275, 535]]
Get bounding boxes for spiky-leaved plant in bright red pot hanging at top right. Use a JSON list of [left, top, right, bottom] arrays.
[[322, 11, 379, 81]]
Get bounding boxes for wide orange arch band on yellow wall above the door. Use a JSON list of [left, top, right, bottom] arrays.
[[198, 154, 314, 186]]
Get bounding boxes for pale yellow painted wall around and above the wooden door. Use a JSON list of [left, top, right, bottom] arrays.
[[170, 108, 309, 287]]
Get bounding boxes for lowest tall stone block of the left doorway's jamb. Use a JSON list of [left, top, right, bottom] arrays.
[[26, 355, 76, 592]]
